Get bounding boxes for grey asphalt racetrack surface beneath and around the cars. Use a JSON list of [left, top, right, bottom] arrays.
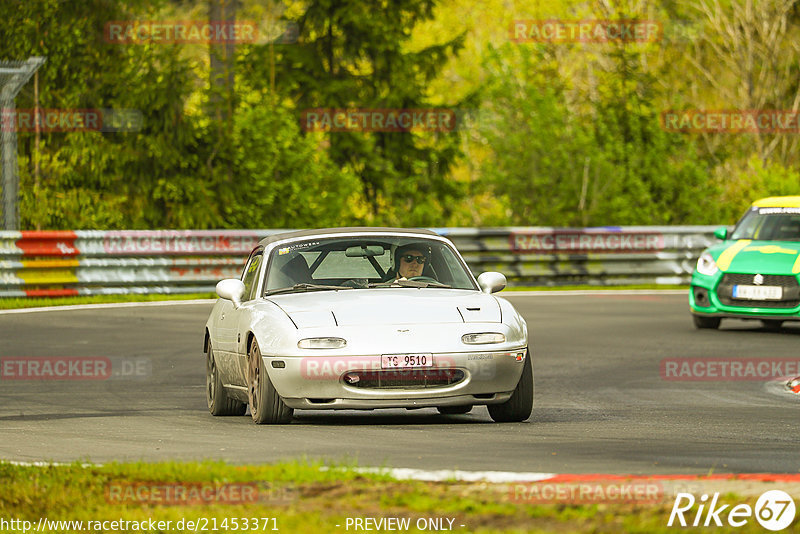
[[0, 292, 800, 474]]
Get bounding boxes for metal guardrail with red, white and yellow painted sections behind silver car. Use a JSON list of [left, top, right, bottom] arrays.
[[0, 226, 716, 297]]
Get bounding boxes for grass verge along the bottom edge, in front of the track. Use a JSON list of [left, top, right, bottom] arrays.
[[0, 462, 780, 533]]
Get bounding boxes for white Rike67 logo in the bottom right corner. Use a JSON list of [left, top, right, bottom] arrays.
[[667, 490, 795, 531]]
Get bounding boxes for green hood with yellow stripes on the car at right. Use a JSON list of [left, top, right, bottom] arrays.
[[708, 239, 800, 274]]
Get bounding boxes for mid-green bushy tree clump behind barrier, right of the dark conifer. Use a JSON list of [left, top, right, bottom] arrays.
[[481, 39, 707, 226]]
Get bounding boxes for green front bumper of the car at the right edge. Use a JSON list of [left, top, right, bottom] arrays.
[[689, 271, 800, 321]]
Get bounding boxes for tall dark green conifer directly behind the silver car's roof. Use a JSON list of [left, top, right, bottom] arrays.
[[242, 0, 464, 225]]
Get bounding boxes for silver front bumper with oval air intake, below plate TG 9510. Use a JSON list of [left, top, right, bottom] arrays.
[[262, 347, 529, 410]]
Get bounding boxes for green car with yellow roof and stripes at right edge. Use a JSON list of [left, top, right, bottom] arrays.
[[689, 196, 800, 330]]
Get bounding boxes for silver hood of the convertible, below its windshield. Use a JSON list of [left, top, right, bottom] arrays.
[[268, 288, 501, 328]]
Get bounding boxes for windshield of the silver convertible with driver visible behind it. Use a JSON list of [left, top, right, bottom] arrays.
[[265, 236, 477, 293]]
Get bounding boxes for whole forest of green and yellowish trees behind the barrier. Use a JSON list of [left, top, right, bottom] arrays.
[[0, 0, 800, 229]]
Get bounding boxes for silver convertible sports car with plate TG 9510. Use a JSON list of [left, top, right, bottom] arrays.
[[204, 228, 533, 424]]
